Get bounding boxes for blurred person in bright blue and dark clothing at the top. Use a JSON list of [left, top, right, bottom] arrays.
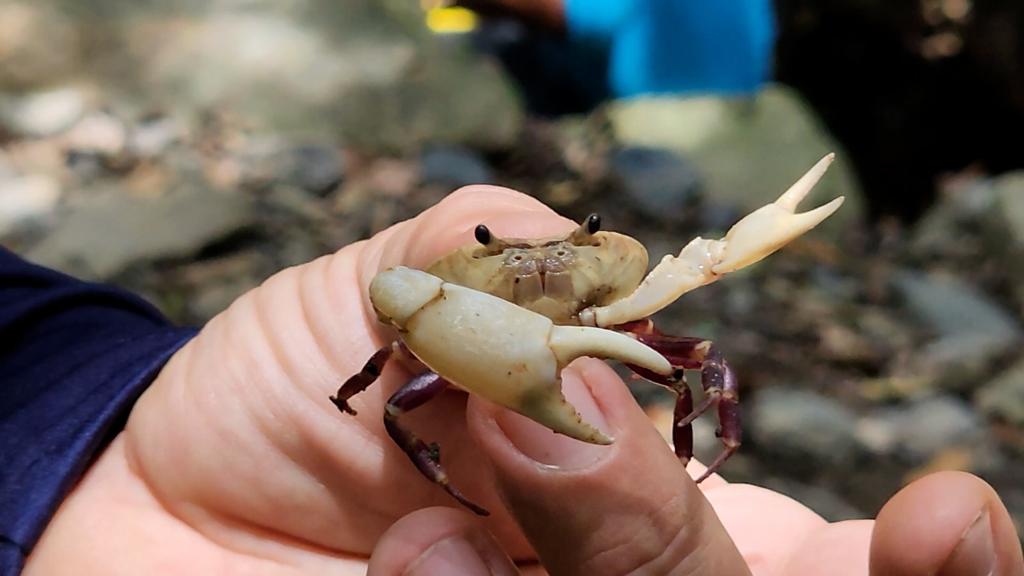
[[457, 0, 775, 114]]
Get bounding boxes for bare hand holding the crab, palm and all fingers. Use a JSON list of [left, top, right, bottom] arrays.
[[26, 187, 1024, 576]]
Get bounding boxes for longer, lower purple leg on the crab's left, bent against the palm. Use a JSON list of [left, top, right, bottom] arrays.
[[384, 372, 490, 516]]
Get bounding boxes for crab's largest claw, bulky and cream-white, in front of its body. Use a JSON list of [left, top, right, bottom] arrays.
[[370, 268, 673, 444]]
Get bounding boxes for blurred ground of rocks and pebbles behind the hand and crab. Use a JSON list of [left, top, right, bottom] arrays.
[[0, 0, 1024, 537]]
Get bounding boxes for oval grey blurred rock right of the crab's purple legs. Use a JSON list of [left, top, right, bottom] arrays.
[[748, 387, 857, 463]]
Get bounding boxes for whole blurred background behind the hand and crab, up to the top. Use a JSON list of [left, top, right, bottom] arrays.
[[0, 0, 1024, 530]]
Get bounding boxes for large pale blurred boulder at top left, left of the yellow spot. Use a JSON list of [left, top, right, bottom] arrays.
[[116, 0, 522, 151]]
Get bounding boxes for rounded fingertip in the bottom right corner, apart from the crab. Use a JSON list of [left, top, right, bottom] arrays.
[[870, 471, 1024, 576]]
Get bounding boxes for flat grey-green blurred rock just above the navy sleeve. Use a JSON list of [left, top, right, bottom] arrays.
[[27, 181, 255, 279]]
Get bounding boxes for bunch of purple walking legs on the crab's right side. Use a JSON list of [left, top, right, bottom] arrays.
[[615, 319, 742, 484]]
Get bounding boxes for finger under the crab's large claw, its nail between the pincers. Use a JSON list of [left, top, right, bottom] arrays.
[[469, 360, 750, 575]]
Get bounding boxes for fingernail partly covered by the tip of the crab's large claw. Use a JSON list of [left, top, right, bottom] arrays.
[[495, 368, 611, 469]]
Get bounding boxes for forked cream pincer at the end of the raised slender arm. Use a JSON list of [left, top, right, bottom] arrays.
[[712, 154, 844, 274]]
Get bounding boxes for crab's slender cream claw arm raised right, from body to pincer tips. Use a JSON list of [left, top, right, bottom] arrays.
[[580, 154, 843, 326]]
